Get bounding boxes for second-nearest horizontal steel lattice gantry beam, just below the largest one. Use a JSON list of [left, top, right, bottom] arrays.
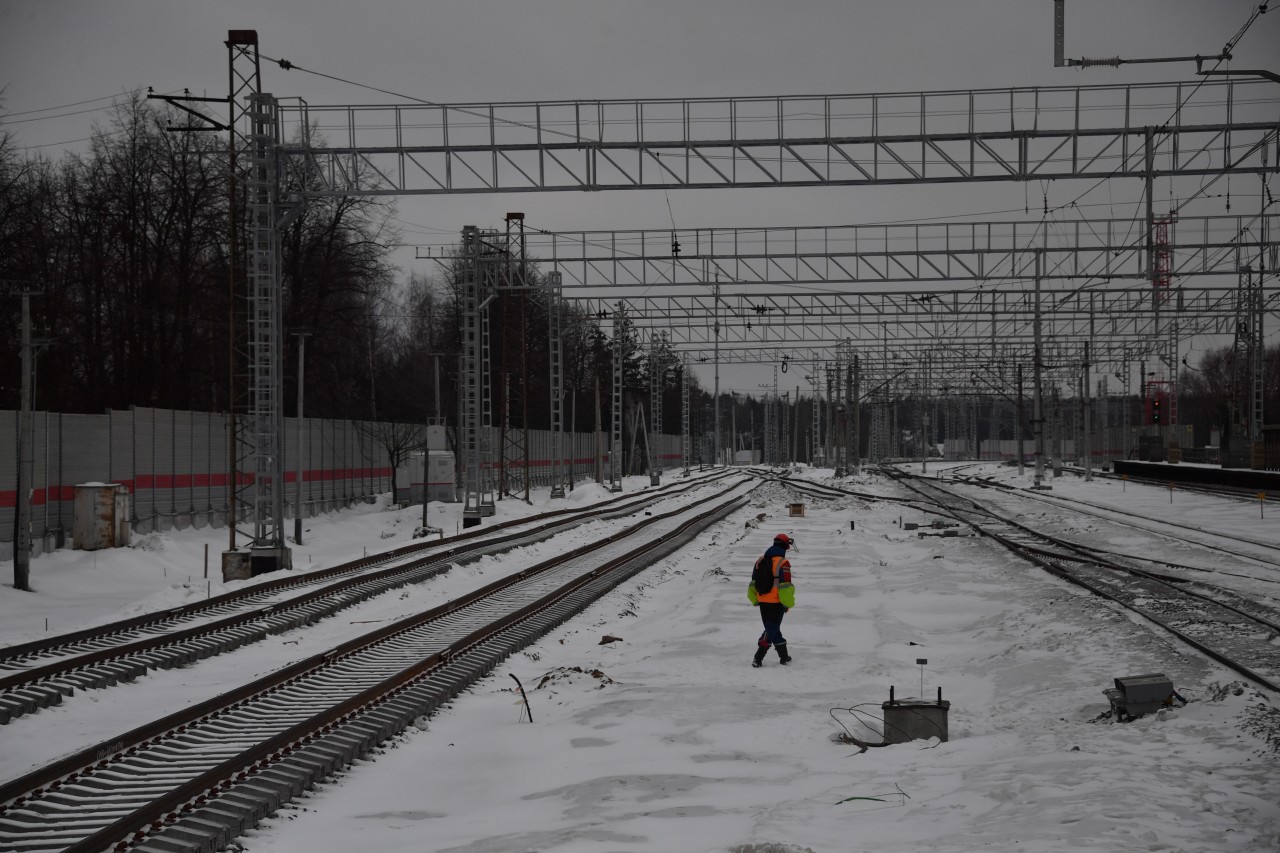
[[512, 213, 1280, 290]]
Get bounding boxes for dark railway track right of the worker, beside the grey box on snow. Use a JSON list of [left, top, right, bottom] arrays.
[[895, 473, 1280, 692]]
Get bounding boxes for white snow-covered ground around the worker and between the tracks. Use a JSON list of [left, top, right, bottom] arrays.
[[0, 465, 1280, 853]]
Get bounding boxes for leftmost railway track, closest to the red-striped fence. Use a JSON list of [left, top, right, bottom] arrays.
[[0, 468, 721, 725]]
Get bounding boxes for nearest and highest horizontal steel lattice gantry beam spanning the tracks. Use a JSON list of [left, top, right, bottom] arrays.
[[275, 79, 1277, 195]]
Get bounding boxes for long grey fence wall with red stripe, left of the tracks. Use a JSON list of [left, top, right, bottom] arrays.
[[0, 407, 681, 560]]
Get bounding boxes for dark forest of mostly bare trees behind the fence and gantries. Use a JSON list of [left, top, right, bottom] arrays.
[[0, 97, 1280, 447]]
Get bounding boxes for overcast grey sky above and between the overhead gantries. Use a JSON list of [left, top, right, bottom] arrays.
[[0, 0, 1280, 389]]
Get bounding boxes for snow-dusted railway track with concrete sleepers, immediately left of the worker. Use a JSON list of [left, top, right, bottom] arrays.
[[0, 483, 756, 853]]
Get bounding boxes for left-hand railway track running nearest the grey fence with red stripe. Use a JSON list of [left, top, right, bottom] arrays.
[[0, 474, 724, 725]]
